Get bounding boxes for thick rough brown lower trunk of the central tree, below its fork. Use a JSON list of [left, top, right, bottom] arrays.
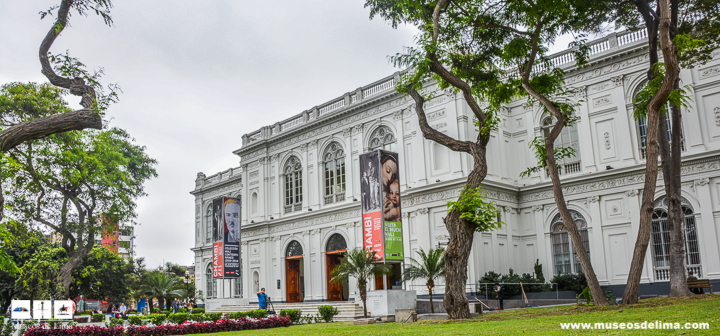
[[443, 159, 487, 319]]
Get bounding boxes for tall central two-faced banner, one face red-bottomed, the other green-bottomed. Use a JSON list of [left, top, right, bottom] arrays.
[[360, 150, 404, 261]]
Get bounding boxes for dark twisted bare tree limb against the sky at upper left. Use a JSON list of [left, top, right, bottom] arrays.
[[0, 0, 117, 152]]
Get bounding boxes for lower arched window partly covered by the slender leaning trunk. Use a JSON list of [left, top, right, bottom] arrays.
[[550, 210, 590, 274]]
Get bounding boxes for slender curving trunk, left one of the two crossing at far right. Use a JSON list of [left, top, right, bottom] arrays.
[[622, 0, 680, 304]]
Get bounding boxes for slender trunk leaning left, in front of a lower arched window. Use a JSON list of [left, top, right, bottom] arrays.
[[545, 142, 609, 306]]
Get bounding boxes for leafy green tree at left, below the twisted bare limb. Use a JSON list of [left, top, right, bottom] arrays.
[[0, 84, 157, 296]]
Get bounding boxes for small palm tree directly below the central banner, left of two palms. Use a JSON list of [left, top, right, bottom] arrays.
[[330, 249, 392, 317]]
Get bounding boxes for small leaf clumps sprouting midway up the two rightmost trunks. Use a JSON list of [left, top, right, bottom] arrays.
[[633, 62, 692, 119]]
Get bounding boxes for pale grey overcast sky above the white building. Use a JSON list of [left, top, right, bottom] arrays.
[[0, 0, 584, 267]]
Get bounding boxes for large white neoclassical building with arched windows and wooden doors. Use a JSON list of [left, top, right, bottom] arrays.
[[191, 32, 720, 302]]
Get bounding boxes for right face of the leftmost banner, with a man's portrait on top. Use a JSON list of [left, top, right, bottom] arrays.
[[223, 197, 240, 278]]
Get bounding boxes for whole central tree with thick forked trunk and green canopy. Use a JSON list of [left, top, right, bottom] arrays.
[[365, 0, 515, 319]]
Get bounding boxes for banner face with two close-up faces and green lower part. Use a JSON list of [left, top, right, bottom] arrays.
[[379, 150, 404, 261]]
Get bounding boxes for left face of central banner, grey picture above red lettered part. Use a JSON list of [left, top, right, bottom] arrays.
[[360, 151, 385, 260]]
